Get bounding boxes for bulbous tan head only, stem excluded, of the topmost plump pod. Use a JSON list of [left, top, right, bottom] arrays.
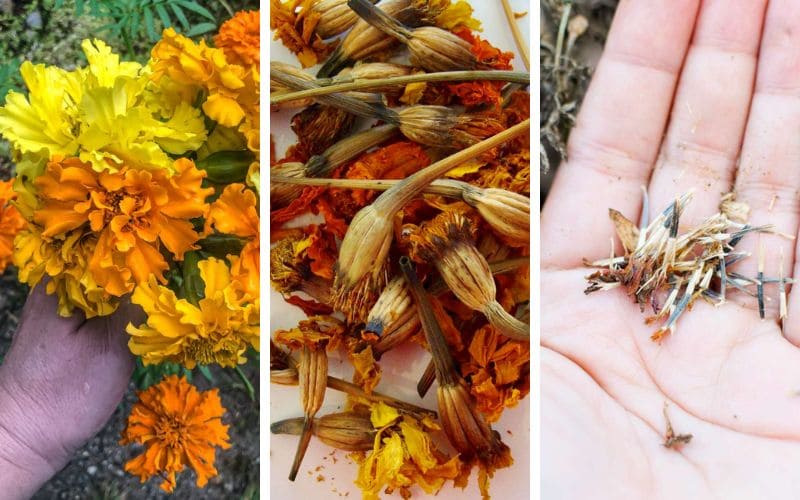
[[407, 26, 478, 72]]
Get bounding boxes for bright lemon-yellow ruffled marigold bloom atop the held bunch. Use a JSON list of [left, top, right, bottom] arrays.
[[0, 40, 206, 176]]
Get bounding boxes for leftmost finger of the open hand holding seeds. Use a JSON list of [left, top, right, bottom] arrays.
[[542, 0, 699, 267]]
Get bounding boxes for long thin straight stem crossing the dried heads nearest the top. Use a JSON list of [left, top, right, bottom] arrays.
[[269, 71, 531, 104]]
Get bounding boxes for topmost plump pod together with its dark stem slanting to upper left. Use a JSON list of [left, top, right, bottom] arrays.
[[348, 0, 478, 72]]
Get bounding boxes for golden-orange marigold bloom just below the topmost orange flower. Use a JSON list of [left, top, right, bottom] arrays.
[[150, 28, 258, 127]]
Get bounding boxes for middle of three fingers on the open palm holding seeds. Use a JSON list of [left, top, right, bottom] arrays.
[[649, 0, 767, 227]]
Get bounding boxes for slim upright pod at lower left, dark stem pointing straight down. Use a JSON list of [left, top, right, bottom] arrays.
[[289, 345, 328, 481]]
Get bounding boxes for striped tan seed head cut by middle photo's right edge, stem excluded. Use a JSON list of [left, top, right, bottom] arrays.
[[462, 187, 531, 247]]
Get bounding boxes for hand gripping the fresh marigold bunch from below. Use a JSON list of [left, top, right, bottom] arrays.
[[0, 284, 142, 499]]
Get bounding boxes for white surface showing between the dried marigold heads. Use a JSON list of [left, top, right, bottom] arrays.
[[270, 0, 536, 500]]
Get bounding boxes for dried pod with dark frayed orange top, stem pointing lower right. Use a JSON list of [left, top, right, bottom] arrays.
[[410, 211, 530, 341]]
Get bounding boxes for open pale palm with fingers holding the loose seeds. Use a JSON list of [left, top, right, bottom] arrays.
[[541, 0, 800, 500]]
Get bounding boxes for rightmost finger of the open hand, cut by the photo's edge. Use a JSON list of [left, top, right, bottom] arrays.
[[736, 0, 800, 326]]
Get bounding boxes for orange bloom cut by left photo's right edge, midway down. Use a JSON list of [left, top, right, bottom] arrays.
[[206, 183, 261, 297]]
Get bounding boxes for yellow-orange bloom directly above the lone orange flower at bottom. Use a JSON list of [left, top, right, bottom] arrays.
[[127, 258, 259, 369]]
